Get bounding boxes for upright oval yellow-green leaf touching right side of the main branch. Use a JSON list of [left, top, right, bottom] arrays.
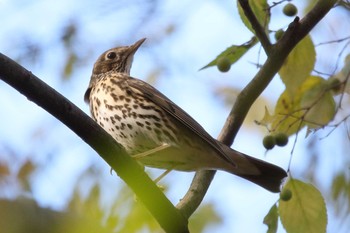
[[278, 36, 316, 97]]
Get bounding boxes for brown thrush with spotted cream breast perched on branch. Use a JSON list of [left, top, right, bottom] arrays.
[[84, 38, 287, 193]]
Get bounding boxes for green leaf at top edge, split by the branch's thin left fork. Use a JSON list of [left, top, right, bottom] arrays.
[[237, 0, 270, 34]]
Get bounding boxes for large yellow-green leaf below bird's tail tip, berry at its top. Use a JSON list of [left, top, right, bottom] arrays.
[[278, 179, 327, 233]]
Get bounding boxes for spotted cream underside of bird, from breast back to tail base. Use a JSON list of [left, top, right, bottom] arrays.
[[90, 89, 232, 171]]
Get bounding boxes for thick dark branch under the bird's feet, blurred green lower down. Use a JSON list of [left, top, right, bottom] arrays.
[[0, 53, 188, 233]]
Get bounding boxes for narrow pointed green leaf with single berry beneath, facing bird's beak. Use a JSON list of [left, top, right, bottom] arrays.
[[200, 37, 258, 70]]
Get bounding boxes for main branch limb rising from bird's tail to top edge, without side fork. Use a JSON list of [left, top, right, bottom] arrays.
[[224, 0, 337, 145]]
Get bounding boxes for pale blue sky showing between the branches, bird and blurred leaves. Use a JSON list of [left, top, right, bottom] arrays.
[[0, 0, 345, 232]]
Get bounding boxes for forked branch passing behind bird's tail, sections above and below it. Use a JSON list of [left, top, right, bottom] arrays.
[[177, 0, 336, 216]]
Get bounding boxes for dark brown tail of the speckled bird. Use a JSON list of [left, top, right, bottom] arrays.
[[220, 143, 287, 193]]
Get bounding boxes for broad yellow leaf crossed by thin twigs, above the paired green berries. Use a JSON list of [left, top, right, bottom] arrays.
[[265, 76, 336, 135]]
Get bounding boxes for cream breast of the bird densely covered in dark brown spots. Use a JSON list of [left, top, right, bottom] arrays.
[[90, 76, 177, 154]]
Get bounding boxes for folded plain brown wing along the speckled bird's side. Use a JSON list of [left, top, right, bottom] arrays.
[[127, 77, 237, 166]]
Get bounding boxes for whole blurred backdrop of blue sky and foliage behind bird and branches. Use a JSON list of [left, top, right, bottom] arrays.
[[0, 0, 350, 232]]
